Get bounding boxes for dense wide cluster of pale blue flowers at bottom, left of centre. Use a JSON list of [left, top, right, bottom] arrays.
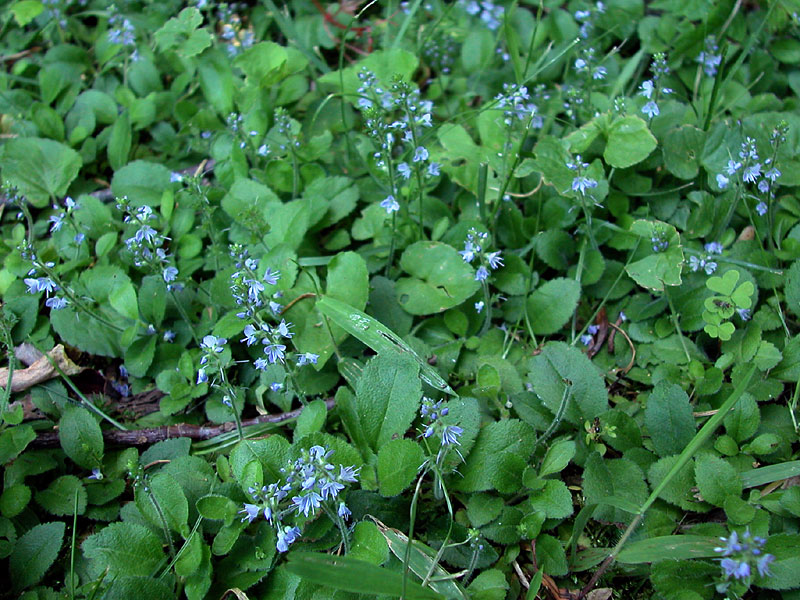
[[239, 446, 359, 552]]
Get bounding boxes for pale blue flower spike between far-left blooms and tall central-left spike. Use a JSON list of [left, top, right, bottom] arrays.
[[117, 197, 182, 291]]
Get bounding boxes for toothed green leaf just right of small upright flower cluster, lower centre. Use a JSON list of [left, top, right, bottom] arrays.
[[454, 419, 536, 492]]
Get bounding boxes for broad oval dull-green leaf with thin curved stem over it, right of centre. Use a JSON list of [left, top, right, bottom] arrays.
[[526, 342, 608, 426]]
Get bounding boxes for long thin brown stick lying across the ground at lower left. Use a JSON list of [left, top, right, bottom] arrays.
[[31, 398, 336, 448]]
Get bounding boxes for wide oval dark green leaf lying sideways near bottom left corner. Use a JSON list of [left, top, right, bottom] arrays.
[[81, 522, 165, 577]]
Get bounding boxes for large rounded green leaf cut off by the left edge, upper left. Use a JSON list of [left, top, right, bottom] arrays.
[[0, 137, 83, 208]]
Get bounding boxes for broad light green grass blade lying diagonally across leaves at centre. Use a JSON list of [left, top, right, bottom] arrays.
[[317, 296, 456, 396]]
